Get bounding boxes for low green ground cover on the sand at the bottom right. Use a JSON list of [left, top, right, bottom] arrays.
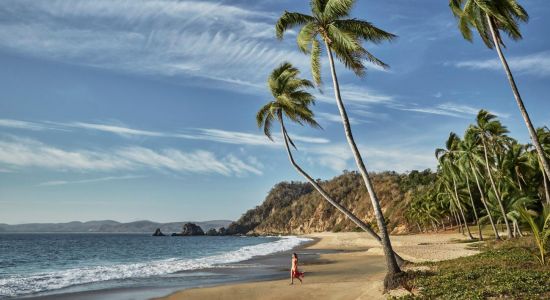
[[396, 239, 550, 299]]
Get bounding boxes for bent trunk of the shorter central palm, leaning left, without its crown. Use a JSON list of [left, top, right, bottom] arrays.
[[280, 118, 404, 265]]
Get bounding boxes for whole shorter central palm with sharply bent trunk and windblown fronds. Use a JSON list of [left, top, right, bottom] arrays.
[[256, 62, 404, 264]]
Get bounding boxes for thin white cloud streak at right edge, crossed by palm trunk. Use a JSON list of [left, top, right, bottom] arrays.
[[447, 51, 550, 77]]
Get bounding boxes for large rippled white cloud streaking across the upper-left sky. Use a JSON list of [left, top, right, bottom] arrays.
[[0, 0, 307, 89]]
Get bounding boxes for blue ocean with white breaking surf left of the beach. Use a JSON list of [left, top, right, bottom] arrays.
[[0, 233, 309, 299]]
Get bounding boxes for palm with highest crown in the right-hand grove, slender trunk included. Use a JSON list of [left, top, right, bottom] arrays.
[[471, 110, 512, 238]]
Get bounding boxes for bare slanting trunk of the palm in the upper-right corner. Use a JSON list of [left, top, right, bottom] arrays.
[[486, 15, 550, 185]]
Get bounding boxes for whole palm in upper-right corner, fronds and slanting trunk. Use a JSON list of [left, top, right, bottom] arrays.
[[449, 0, 550, 188]]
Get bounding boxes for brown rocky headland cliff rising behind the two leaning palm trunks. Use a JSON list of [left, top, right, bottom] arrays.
[[229, 170, 433, 234]]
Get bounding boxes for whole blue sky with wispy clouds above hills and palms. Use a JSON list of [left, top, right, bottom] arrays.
[[0, 0, 550, 223]]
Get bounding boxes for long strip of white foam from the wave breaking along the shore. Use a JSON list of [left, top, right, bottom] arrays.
[[0, 236, 310, 297]]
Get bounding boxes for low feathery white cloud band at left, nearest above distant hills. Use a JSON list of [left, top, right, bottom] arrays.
[[0, 138, 262, 176]]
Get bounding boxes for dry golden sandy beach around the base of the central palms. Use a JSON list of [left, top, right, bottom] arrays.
[[158, 232, 477, 300]]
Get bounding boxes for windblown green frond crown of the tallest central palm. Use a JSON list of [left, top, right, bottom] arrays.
[[275, 0, 396, 85]]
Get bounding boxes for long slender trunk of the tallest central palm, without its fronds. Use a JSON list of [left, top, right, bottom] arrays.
[[325, 41, 401, 275]]
